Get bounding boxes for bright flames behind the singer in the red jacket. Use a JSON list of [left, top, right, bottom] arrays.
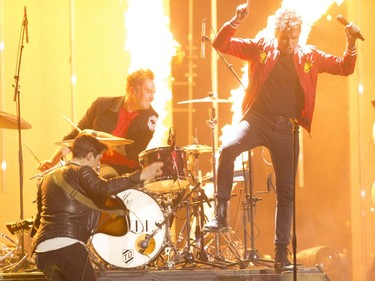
[[219, 0, 344, 169]]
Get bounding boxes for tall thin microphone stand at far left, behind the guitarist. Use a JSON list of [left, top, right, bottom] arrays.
[[8, 6, 29, 272]]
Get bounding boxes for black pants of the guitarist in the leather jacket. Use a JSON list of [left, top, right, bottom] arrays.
[[36, 243, 97, 281]]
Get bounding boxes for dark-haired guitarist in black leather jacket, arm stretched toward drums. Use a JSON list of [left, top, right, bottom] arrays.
[[33, 134, 163, 281]]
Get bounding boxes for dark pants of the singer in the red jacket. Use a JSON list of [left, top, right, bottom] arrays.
[[217, 113, 299, 244]]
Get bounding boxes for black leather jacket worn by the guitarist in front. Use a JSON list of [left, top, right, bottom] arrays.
[[33, 164, 140, 248]]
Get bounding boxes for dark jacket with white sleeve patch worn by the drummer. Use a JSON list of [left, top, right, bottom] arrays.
[[63, 96, 158, 174]]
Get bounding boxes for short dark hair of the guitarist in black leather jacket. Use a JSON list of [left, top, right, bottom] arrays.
[[72, 134, 108, 158]]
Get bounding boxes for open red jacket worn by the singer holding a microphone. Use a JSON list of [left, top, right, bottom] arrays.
[[213, 22, 356, 133]]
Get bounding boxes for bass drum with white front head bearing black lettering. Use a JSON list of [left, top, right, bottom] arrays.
[[91, 189, 167, 268]]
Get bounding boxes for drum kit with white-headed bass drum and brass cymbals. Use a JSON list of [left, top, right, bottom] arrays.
[[0, 95, 244, 269]]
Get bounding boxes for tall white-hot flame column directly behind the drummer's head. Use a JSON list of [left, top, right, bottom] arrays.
[[125, 0, 178, 148]]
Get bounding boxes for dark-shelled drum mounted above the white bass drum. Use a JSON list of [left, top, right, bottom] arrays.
[[139, 147, 189, 193]]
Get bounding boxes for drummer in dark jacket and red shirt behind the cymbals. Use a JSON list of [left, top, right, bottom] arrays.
[[38, 69, 158, 177]]
